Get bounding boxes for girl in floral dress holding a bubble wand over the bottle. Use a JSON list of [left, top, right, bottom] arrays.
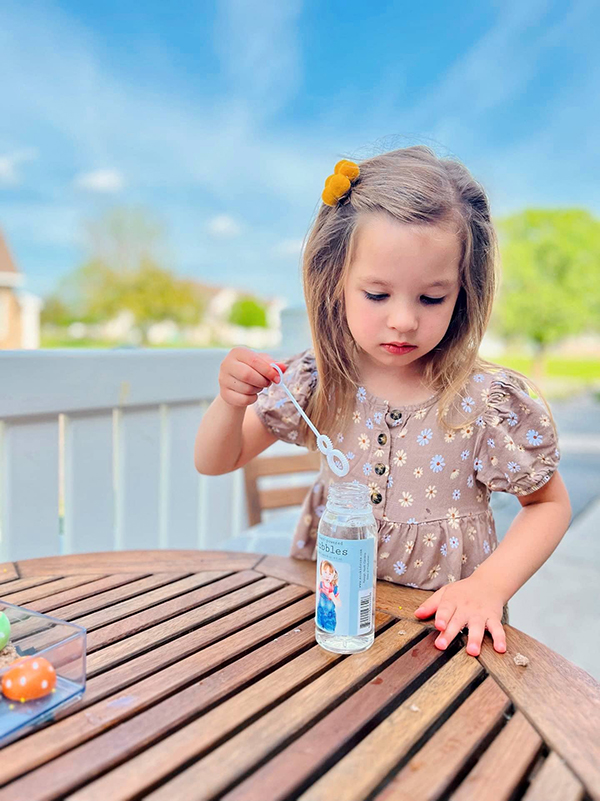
[[195, 146, 571, 656]]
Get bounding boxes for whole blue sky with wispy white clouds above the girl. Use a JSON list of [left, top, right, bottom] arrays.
[[0, 0, 600, 305]]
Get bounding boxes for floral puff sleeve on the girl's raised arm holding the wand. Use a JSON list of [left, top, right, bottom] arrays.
[[252, 349, 317, 446]]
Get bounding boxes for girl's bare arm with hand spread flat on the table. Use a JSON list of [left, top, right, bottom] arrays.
[[415, 471, 572, 656]]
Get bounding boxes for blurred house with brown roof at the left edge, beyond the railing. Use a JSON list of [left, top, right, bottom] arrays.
[[0, 231, 42, 350]]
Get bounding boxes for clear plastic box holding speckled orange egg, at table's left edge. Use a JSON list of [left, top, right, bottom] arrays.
[[0, 600, 86, 747]]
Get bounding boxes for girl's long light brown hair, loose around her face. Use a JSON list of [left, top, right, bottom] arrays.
[[300, 145, 556, 450]]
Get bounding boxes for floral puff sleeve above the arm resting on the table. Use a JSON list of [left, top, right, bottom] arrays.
[[473, 373, 560, 495]]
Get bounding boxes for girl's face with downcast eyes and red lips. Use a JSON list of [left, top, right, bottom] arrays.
[[344, 214, 460, 378]]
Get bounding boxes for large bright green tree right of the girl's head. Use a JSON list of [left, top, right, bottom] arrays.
[[492, 209, 600, 380]]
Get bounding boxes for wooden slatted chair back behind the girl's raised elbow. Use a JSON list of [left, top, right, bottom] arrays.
[[244, 451, 321, 526]]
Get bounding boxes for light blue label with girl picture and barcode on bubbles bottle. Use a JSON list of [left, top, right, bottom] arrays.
[[315, 534, 375, 637]]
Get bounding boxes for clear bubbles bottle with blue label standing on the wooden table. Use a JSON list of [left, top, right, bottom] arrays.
[[315, 482, 377, 654]]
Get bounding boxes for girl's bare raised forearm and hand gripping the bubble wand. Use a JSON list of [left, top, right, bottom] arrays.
[[194, 348, 279, 476]]
